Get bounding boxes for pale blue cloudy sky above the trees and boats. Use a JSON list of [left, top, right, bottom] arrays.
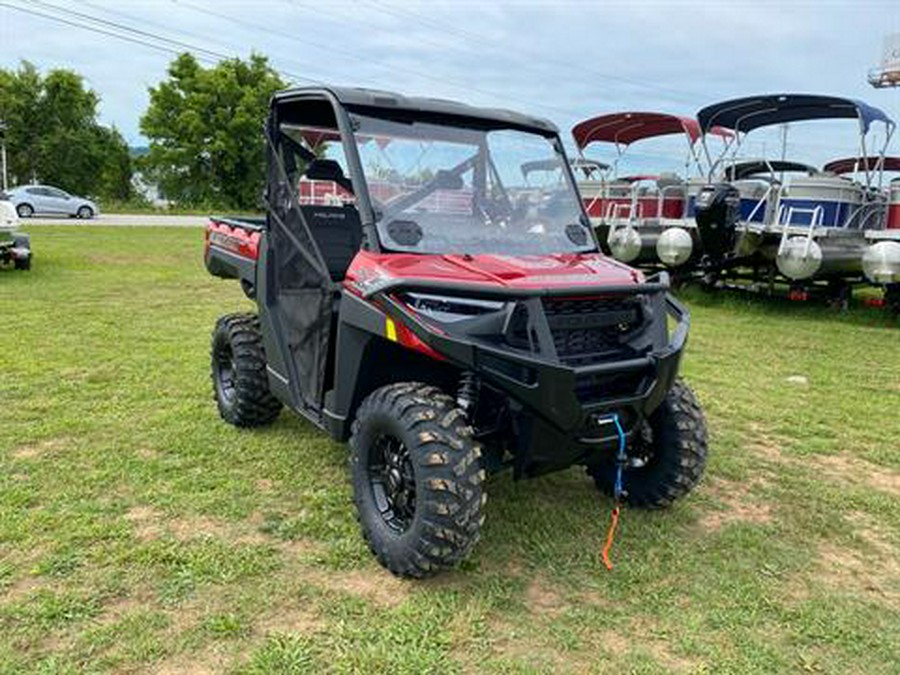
[[0, 0, 900, 170]]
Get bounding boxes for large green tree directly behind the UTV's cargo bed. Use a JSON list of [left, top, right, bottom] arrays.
[[140, 54, 285, 209]]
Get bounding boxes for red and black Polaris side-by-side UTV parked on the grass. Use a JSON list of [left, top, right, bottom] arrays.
[[205, 88, 707, 577]]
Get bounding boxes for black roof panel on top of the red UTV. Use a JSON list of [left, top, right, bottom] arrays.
[[274, 86, 559, 134]]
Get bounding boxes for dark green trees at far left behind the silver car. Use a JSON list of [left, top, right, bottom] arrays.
[[0, 61, 131, 199]]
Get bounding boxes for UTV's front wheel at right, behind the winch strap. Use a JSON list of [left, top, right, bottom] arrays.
[[588, 379, 708, 509]]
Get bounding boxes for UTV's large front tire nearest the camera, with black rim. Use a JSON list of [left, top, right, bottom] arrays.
[[350, 382, 486, 578]]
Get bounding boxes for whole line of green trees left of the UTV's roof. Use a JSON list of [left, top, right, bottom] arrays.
[[0, 54, 286, 210]]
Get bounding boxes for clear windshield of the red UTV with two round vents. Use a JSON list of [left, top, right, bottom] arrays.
[[355, 115, 595, 255]]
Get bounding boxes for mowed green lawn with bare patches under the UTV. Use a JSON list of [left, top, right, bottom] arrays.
[[0, 227, 900, 674]]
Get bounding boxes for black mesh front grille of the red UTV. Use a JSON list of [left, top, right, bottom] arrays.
[[543, 297, 643, 366]]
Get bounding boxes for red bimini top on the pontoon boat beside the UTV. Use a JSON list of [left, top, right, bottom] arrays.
[[572, 112, 734, 150]]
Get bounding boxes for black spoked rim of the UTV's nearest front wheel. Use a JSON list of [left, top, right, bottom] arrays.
[[368, 434, 416, 534]]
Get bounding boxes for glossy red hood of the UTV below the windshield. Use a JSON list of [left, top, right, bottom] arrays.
[[347, 251, 644, 289]]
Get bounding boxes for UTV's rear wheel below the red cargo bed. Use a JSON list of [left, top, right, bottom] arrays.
[[210, 314, 281, 427]]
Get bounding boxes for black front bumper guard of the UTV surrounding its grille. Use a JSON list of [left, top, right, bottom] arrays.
[[381, 273, 690, 474]]
